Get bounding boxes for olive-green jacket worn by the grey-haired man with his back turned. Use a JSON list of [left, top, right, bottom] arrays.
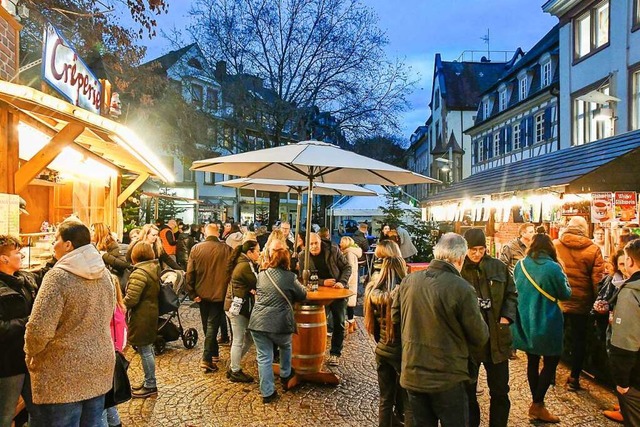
[[392, 260, 489, 393]]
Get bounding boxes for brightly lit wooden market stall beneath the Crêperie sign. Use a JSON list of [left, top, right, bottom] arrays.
[[0, 80, 173, 233]]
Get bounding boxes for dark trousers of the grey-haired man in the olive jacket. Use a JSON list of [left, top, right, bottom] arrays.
[[407, 382, 469, 427]]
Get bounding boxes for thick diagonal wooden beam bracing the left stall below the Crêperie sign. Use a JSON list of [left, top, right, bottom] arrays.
[[15, 123, 84, 193]]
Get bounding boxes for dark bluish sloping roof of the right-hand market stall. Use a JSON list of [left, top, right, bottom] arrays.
[[425, 131, 640, 205]]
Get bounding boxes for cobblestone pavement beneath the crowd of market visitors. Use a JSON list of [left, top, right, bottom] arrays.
[[119, 305, 618, 427]]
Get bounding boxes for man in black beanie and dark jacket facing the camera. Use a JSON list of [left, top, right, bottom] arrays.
[[460, 228, 518, 427]]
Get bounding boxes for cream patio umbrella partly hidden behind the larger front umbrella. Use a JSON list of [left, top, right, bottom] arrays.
[[219, 178, 377, 242]]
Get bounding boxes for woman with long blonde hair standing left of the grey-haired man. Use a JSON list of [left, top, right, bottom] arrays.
[[364, 240, 411, 427]]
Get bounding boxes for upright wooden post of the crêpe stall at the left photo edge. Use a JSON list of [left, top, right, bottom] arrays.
[[0, 108, 19, 194]]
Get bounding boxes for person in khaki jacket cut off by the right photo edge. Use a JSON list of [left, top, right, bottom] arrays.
[[609, 239, 640, 427]]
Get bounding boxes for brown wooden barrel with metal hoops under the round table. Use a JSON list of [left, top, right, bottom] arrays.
[[292, 304, 327, 374]]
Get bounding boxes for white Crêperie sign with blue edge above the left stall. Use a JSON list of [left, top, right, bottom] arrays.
[[42, 24, 102, 114]]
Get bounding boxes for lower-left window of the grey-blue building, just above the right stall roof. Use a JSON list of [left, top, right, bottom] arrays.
[[573, 85, 613, 145]]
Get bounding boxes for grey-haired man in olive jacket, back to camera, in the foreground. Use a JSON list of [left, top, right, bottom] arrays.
[[392, 233, 489, 427]]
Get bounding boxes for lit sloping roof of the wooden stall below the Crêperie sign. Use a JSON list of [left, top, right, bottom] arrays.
[[0, 80, 174, 182]]
